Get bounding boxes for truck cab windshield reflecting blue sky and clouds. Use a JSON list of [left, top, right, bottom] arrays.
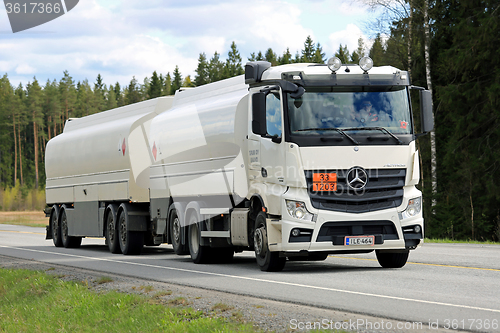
[[288, 87, 412, 136]]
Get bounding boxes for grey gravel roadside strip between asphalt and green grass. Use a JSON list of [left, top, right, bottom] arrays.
[[0, 255, 449, 333]]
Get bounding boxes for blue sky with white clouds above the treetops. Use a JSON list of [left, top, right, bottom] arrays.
[[0, 0, 374, 86]]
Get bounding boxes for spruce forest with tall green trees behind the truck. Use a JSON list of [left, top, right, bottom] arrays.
[[0, 0, 500, 241]]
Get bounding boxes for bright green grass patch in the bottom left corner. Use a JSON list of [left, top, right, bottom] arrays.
[[0, 269, 255, 332]]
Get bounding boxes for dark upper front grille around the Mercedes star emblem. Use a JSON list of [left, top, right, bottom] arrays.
[[305, 169, 406, 213]]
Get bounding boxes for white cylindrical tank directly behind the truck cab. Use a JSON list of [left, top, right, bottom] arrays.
[[149, 76, 248, 208]]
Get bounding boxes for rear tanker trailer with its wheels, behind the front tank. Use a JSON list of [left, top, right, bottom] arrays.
[[45, 97, 173, 254]]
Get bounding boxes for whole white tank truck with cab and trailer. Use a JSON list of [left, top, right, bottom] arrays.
[[45, 58, 433, 271]]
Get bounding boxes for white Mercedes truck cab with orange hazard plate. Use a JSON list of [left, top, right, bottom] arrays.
[[245, 58, 433, 269]]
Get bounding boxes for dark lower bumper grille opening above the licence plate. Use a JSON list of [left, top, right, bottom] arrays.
[[316, 221, 399, 245]]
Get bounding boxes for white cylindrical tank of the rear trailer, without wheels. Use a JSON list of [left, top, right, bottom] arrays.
[[45, 97, 173, 204]]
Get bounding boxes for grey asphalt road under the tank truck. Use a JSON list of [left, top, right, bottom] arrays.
[[0, 225, 500, 332]]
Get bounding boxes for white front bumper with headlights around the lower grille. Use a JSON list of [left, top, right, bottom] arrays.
[[267, 188, 424, 250]]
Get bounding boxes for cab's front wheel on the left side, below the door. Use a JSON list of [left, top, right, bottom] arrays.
[[253, 212, 286, 272]]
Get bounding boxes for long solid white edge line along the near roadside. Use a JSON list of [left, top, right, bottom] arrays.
[[0, 245, 500, 313]]
